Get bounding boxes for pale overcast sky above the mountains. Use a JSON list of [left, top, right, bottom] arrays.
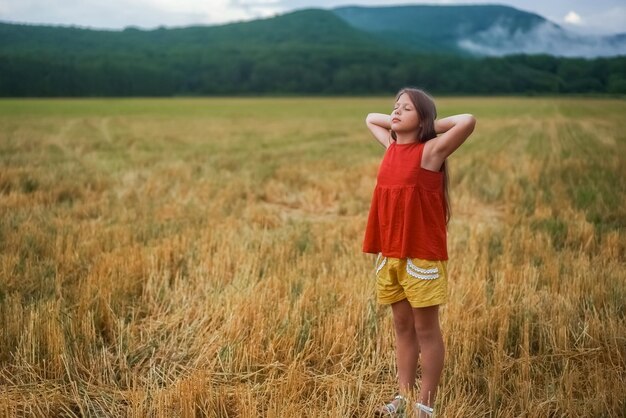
[[0, 0, 626, 34]]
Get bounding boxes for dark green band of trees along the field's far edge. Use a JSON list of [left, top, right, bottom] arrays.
[[0, 44, 626, 97]]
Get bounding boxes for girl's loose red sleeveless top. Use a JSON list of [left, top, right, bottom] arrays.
[[363, 141, 448, 260]]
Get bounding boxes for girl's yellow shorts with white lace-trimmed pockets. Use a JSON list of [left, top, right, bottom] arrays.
[[376, 254, 448, 308]]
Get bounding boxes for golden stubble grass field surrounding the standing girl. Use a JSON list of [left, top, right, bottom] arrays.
[[0, 98, 626, 417]]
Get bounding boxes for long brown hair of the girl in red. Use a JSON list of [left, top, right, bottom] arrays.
[[391, 87, 452, 225]]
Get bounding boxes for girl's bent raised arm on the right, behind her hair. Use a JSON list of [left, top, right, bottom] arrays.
[[428, 113, 476, 165]]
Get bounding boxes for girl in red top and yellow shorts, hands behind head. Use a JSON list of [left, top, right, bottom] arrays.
[[363, 88, 476, 418]]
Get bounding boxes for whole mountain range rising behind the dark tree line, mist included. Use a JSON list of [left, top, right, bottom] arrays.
[[0, 5, 626, 58]]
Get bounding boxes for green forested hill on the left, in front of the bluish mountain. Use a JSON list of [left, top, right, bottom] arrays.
[[0, 9, 384, 54]]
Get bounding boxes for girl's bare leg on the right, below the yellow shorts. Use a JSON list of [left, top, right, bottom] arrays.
[[413, 305, 445, 406]]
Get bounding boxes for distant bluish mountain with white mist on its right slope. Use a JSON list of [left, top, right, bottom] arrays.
[[332, 5, 626, 58]]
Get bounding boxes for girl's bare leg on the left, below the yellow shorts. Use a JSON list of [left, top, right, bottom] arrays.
[[391, 299, 420, 393]]
